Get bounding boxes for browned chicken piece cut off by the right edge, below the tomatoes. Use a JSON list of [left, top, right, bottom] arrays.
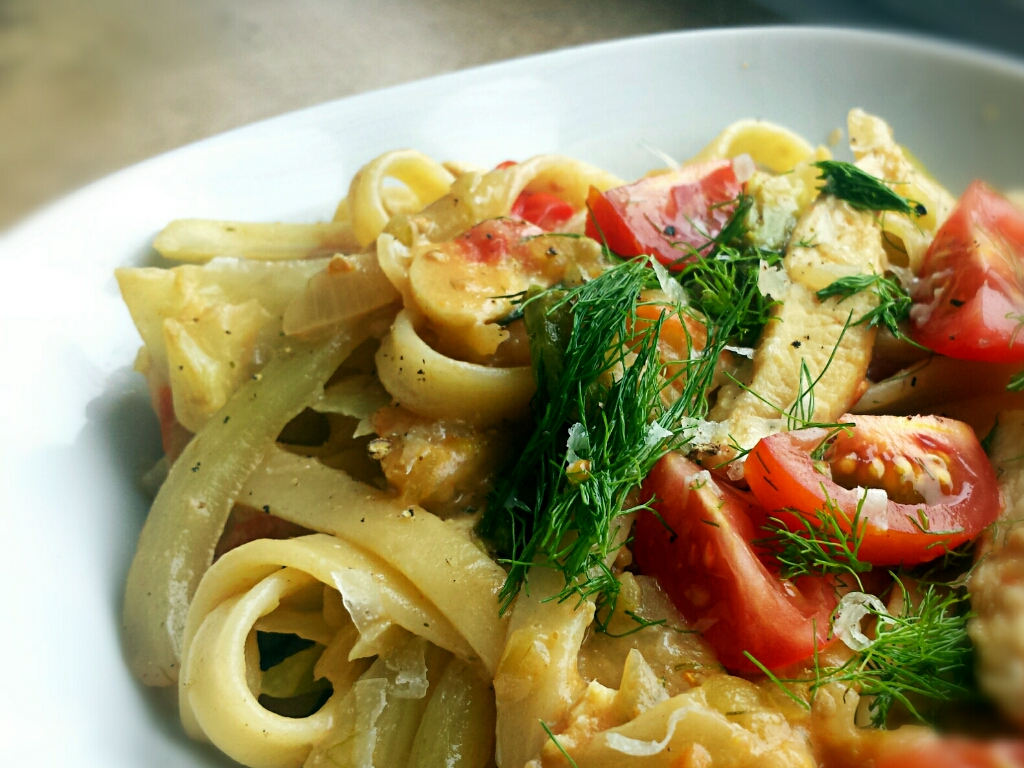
[[968, 411, 1024, 727]]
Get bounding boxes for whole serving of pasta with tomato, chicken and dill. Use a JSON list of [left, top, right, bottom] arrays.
[[117, 110, 1024, 768]]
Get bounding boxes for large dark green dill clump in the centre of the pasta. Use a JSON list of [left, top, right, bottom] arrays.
[[480, 258, 756, 611]]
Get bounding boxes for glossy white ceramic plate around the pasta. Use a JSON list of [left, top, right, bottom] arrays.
[[0, 28, 1024, 768]]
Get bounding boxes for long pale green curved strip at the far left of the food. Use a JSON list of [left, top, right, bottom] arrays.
[[122, 328, 365, 685]]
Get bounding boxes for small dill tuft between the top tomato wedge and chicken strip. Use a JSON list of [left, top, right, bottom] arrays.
[[678, 246, 782, 346]]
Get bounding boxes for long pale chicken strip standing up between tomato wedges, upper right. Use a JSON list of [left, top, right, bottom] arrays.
[[701, 110, 952, 470]]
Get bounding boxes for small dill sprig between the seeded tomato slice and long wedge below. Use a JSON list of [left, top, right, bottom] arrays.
[[754, 493, 871, 589]]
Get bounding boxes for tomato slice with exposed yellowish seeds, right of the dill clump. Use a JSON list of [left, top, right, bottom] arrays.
[[743, 415, 999, 565]]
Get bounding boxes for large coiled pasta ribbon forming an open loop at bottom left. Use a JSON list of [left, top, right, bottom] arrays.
[[179, 536, 474, 768]]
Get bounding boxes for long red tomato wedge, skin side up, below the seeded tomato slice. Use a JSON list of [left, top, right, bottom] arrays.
[[633, 454, 837, 672]]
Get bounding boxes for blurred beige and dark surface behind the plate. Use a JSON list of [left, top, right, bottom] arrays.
[[0, 0, 1024, 229]]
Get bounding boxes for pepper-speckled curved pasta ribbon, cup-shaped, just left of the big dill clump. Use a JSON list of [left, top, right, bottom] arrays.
[[377, 310, 537, 426]]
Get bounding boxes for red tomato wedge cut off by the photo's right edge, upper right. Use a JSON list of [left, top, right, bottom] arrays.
[[911, 181, 1024, 362]]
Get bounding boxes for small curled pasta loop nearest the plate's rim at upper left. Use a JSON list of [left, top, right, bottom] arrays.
[[346, 150, 455, 247]]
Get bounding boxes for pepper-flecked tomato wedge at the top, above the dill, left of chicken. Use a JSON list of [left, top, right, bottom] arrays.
[[587, 160, 743, 269]]
